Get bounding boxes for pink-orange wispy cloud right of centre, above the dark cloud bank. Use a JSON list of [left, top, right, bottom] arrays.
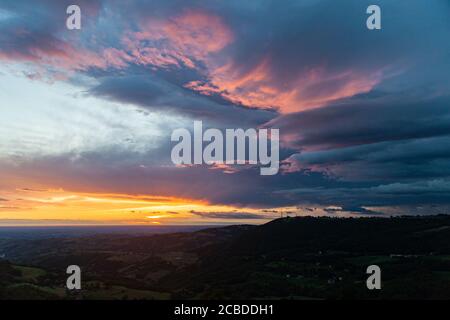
[[186, 57, 382, 113]]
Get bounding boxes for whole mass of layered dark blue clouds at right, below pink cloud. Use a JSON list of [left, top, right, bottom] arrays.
[[272, 92, 450, 188]]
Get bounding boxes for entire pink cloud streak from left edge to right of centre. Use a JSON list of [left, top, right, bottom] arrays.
[[0, 10, 382, 113]]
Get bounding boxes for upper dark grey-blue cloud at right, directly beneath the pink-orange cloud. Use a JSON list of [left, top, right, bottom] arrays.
[[267, 92, 450, 149]]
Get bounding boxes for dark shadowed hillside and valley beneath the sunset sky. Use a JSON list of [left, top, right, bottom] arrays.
[[0, 216, 450, 299]]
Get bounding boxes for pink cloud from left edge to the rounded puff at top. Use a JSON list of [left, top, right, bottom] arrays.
[[0, 10, 233, 76]]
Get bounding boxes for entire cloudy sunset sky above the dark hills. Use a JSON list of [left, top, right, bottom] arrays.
[[0, 0, 450, 226]]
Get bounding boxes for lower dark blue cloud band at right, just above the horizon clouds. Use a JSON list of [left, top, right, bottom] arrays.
[[290, 136, 450, 181]]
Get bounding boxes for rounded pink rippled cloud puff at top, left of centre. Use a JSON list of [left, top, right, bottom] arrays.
[[118, 10, 233, 68]]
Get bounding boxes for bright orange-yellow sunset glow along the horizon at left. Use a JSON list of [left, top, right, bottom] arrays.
[[0, 189, 284, 226]]
